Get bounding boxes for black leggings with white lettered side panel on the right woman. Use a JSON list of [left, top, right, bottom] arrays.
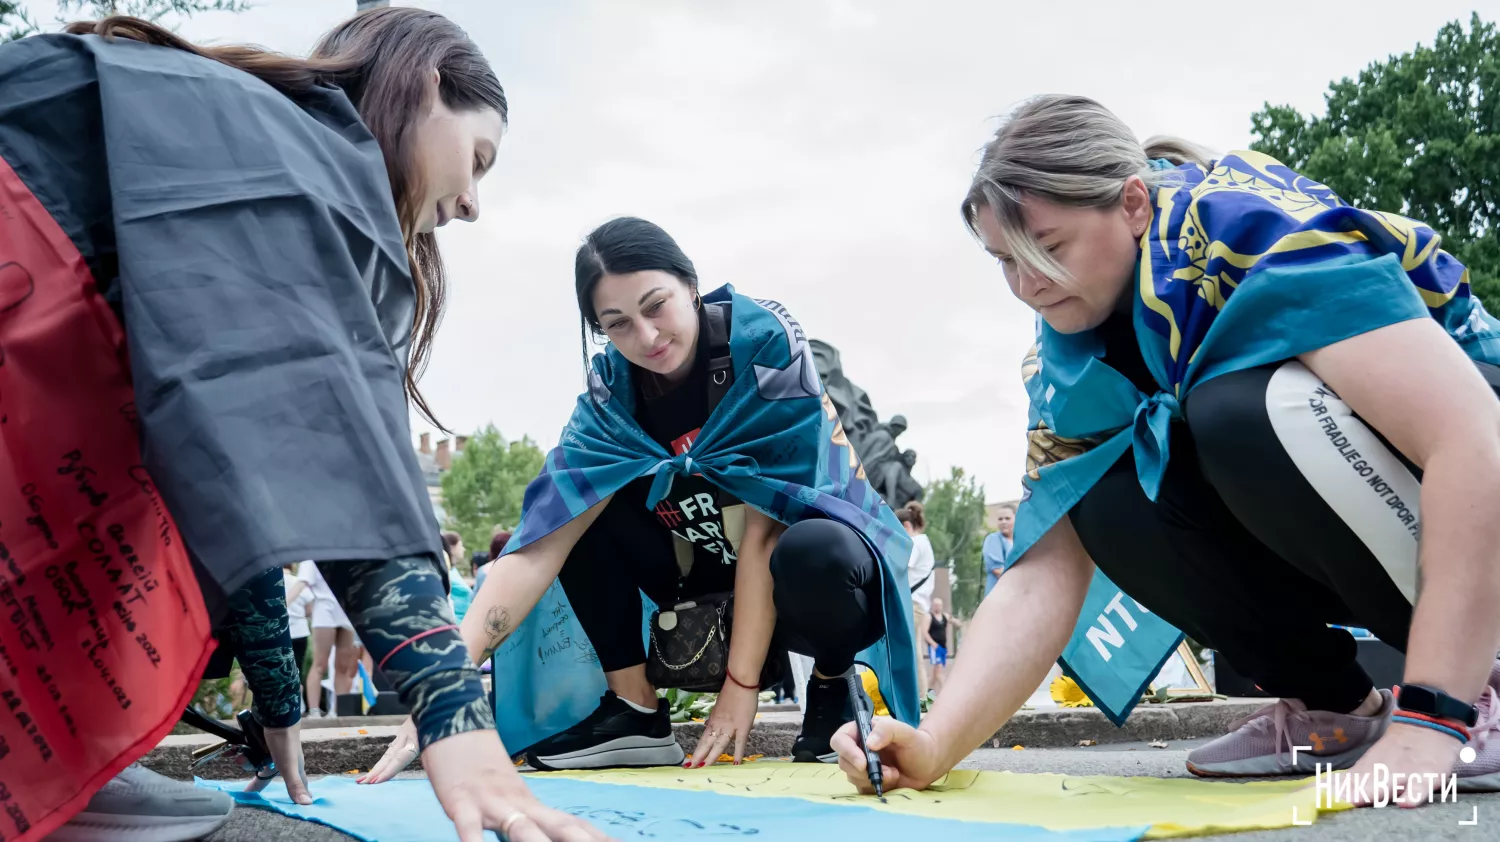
[[1071, 362, 1500, 713]]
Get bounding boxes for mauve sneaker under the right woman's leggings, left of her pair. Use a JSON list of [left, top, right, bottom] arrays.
[[1188, 690, 1395, 777]]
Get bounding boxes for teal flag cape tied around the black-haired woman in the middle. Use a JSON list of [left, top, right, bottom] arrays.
[[494, 287, 920, 752]]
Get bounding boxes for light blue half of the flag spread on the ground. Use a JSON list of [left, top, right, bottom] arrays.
[[198, 776, 1148, 842]]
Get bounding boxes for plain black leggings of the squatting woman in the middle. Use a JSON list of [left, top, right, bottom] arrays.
[[558, 495, 885, 675]]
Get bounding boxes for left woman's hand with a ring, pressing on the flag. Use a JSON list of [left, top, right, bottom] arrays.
[[422, 729, 608, 842]]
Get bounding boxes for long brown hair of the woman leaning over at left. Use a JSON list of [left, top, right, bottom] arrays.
[[66, 8, 510, 429]]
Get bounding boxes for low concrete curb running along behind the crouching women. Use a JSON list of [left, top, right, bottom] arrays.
[[141, 699, 1271, 780]]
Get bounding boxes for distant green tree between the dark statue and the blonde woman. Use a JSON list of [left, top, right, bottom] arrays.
[[923, 467, 984, 617]]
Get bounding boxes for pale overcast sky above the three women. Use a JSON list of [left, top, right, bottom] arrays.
[[33, 0, 1500, 500]]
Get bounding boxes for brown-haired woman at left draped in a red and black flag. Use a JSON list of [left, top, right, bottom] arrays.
[[0, 9, 594, 842]]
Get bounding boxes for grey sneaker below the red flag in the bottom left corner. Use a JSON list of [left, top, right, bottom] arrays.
[[48, 762, 234, 842]]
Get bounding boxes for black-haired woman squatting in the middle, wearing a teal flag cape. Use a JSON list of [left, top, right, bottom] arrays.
[[366, 219, 918, 782]]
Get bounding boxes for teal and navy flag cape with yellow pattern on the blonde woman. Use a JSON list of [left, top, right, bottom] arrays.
[[1008, 152, 1500, 725]]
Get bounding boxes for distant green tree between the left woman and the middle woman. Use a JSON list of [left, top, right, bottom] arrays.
[[443, 425, 545, 551]]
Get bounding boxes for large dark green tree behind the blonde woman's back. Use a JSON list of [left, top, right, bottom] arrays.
[[1251, 14, 1500, 312]]
